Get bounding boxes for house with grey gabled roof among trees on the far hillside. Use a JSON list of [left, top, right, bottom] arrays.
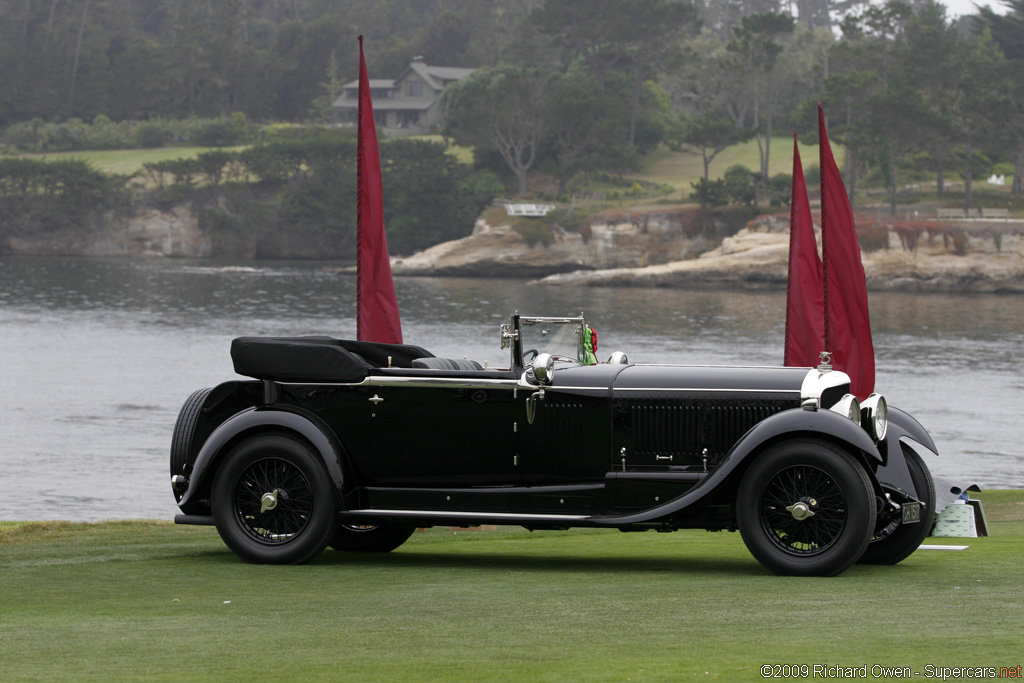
[[332, 57, 475, 135]]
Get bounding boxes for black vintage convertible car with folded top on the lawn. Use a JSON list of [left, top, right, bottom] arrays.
[[171, 315, 936, 575]]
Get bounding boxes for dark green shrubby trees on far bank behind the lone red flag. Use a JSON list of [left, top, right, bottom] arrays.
[[189, 133, 502, 255]]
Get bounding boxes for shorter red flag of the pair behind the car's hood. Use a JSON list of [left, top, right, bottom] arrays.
[[783, 133, 825, 368]]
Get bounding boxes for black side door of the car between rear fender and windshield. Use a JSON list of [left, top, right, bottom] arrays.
[[367, 371, 518, 487]]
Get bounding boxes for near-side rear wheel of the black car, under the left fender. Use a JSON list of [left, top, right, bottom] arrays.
[[210, 434, 338, 564]]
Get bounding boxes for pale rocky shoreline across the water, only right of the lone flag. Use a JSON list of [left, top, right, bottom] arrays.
[[392, 209, 1024, 294]]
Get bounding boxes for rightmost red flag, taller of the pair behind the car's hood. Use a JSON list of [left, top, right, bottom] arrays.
[[818, 104, 874, 399]]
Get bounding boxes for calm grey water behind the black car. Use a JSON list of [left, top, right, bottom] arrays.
[[0, 257, 1024, 521]]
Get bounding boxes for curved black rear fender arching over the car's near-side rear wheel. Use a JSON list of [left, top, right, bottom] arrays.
[[178, 407, 344, 510]]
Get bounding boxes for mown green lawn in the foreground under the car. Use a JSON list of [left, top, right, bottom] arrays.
[[0, 492, 1024, 681]]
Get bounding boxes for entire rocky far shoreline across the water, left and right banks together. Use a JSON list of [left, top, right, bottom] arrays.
[[9, 207, 1024, 294]]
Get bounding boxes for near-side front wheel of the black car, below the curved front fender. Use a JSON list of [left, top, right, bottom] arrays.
[[736, 440, 876, 577]]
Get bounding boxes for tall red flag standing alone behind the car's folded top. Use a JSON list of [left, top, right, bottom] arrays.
[[355, 36, 401, 344]]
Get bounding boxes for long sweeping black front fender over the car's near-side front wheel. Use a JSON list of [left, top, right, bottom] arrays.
[[594, 409, 882, 526]]
